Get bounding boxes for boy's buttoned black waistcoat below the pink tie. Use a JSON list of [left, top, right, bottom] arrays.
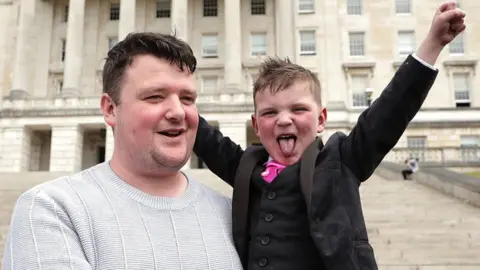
[[246, 163, 325, 270]]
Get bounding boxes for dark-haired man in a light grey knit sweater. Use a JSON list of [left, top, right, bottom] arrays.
[[3, 33, 241, 270]]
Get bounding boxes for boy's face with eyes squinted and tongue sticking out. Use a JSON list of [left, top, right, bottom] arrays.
[[252, 82, 327, 165]]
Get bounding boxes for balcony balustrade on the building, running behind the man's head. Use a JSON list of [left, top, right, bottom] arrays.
[[0, 92, 252, 110]]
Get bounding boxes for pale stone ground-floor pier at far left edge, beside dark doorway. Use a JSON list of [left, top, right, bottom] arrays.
[[0, 127, 31, 172]]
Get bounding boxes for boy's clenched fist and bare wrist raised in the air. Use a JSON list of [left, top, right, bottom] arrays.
[[417, 1, 466, 65]]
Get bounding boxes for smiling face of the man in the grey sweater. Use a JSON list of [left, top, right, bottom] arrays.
[[102, 55, 198, 170]]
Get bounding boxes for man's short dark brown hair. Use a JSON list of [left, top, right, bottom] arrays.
[[102, 32, 197, 105]]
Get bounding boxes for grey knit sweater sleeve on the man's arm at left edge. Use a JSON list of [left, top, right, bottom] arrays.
[[3, 188, 92, 270]]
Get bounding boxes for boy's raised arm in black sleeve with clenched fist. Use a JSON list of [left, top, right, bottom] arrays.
[[341, 2, 465, 181]]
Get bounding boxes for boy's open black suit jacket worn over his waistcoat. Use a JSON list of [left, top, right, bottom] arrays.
[[194, 55, 438, 270]]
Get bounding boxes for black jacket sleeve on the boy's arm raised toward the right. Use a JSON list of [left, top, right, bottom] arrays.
[[340, 55, 438, 181]]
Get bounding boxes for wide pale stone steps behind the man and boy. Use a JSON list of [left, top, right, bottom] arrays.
[[0, 170, 480, 270]]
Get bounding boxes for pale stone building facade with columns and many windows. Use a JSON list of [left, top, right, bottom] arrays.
[[0, 0, 480, 171]]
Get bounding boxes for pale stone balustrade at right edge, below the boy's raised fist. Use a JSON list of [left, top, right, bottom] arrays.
[[385, 146, 480, 167]]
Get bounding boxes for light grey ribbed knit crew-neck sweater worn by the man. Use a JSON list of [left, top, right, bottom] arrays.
[[3, 163, 242, 270]]
